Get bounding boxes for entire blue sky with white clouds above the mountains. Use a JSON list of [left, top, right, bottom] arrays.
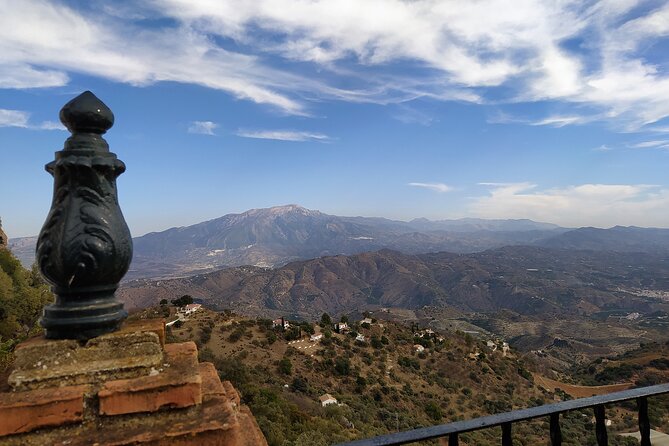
[[0, 0, 669, 237]]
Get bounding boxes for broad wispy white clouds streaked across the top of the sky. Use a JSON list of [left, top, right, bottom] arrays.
[[0, 0, 669, 126]]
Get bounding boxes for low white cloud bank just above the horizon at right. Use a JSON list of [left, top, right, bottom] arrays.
[[468, 183, 669, 227]]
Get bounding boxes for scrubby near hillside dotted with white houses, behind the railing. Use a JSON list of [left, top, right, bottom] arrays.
[[136, 306, 640, 446]]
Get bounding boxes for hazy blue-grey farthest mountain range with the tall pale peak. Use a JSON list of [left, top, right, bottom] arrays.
[[9, 205, 669, 280]]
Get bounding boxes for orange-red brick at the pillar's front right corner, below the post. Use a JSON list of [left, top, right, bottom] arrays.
[[98, 342, 202, 415]]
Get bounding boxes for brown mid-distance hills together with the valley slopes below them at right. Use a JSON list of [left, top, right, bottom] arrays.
[[119, 247, 669, 366]]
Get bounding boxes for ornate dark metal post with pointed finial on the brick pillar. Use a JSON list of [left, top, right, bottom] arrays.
[[37, 91, 132, 339]]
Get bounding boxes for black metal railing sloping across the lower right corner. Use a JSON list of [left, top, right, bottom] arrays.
[[338, 384, 669, 446]]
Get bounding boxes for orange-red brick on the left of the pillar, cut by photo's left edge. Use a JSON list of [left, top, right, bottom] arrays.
[[0, 386, 89, 436]]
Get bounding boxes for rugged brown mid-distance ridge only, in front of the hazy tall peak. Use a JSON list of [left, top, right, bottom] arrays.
[[119, 246, 669, 318]]
